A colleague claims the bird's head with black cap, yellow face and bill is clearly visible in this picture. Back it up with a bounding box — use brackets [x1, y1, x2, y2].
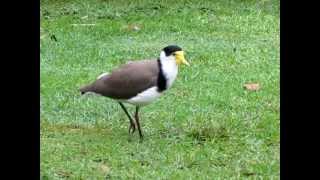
[160, 45, 190, 66]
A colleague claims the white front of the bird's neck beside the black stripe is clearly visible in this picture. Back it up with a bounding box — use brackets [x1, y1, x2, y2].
[160, 51, 178, 89]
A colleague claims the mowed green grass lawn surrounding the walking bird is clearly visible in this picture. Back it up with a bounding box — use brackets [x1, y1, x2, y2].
[40, 0, 280, 180]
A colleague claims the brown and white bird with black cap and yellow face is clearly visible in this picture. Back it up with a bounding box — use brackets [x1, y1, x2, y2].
[79, 45, 190, 139]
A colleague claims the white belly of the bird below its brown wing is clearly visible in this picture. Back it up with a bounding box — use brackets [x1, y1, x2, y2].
[120, 87, 161, 106]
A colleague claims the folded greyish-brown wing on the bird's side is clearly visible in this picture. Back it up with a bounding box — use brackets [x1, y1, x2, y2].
[86, 60, 159, 99]
